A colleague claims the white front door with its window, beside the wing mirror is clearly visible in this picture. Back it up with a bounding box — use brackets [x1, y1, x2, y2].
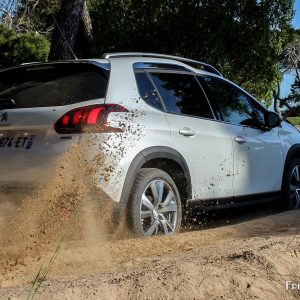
[201, 76, 283, 196]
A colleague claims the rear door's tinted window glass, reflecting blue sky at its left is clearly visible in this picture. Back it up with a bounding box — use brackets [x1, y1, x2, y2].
[149, 72, 214, 119]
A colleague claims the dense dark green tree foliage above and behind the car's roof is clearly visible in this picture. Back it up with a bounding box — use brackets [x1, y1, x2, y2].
[90, 0, 293, 99]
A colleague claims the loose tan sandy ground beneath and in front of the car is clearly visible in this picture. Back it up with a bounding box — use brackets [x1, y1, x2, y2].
[0, 197, 300, 299]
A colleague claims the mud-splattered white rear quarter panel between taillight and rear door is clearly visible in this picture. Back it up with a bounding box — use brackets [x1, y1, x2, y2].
[81, 59, 172, 202]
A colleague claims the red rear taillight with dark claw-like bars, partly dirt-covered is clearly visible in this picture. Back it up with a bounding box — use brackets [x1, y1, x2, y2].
[54, 104, 128, 134]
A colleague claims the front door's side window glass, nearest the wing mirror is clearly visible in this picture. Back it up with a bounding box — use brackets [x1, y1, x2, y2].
[201, 76, 259, 126]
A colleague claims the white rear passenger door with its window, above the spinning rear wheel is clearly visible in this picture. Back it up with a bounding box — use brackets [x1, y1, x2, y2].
[148, 71, 233, 199]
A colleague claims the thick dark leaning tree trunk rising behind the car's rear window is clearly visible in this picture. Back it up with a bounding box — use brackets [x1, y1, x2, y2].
[49, 0, 84, 60]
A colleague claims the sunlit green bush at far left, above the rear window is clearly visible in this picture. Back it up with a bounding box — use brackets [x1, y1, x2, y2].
[0, 25, 50, 67]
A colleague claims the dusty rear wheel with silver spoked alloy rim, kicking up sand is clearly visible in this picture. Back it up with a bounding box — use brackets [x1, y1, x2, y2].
[128, 168, 182, 236]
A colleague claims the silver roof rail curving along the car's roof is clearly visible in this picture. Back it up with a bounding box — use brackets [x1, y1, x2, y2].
[102, 52, 223, 76]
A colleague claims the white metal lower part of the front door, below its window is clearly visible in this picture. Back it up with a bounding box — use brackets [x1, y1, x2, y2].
[231, 125, 284, 196]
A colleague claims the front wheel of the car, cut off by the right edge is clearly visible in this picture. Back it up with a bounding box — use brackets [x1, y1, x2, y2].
[283, 158, 300, 210]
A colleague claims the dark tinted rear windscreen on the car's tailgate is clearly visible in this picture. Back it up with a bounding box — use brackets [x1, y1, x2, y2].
[0, 63, 108, 108]
